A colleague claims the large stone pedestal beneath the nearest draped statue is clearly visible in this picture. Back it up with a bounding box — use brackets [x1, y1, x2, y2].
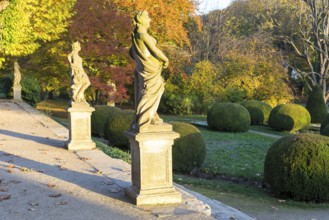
[125, 124, 182, 206]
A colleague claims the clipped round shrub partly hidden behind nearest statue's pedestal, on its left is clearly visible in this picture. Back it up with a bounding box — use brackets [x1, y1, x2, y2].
[104, 110, 134, 149]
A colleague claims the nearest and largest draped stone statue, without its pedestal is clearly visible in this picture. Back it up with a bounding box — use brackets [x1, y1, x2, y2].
[129, 11, 169, 132]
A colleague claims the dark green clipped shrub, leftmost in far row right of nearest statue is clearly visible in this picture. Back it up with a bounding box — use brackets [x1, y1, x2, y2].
[207, 103, 250, 132]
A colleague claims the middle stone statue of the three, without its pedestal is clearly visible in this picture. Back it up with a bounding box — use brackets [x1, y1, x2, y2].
[68, 42, 90, 105]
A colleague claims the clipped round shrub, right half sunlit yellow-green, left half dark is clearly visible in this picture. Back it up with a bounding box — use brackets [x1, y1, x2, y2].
[268, 104, 311, 131]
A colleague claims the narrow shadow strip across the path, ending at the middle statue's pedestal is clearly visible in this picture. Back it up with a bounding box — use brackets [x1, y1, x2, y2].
[0, 129, 66, 148]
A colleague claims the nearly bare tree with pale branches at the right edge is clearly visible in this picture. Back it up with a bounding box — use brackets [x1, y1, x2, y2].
[261, 0, 329, 101]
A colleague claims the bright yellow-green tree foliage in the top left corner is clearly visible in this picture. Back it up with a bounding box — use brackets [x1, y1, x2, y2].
[0, 0, 75, 57]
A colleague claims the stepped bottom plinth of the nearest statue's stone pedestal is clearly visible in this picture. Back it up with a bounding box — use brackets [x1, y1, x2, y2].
[125, 186, 182, 206]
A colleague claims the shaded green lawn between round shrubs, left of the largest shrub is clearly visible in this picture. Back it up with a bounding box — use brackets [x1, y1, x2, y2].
[200, 128, 277, 181]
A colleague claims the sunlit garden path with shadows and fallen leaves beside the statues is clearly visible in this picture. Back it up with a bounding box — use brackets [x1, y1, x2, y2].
[0, 101, 251, 220]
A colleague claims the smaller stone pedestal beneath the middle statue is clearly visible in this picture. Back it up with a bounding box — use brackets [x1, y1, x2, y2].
[67, 105, 96, 151]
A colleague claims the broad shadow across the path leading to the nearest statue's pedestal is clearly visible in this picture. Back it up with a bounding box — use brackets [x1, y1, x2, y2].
[0, 151, 131, 203]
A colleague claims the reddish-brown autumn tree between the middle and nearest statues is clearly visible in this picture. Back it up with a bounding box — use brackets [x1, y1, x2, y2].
[69, 0, 133, 103]
